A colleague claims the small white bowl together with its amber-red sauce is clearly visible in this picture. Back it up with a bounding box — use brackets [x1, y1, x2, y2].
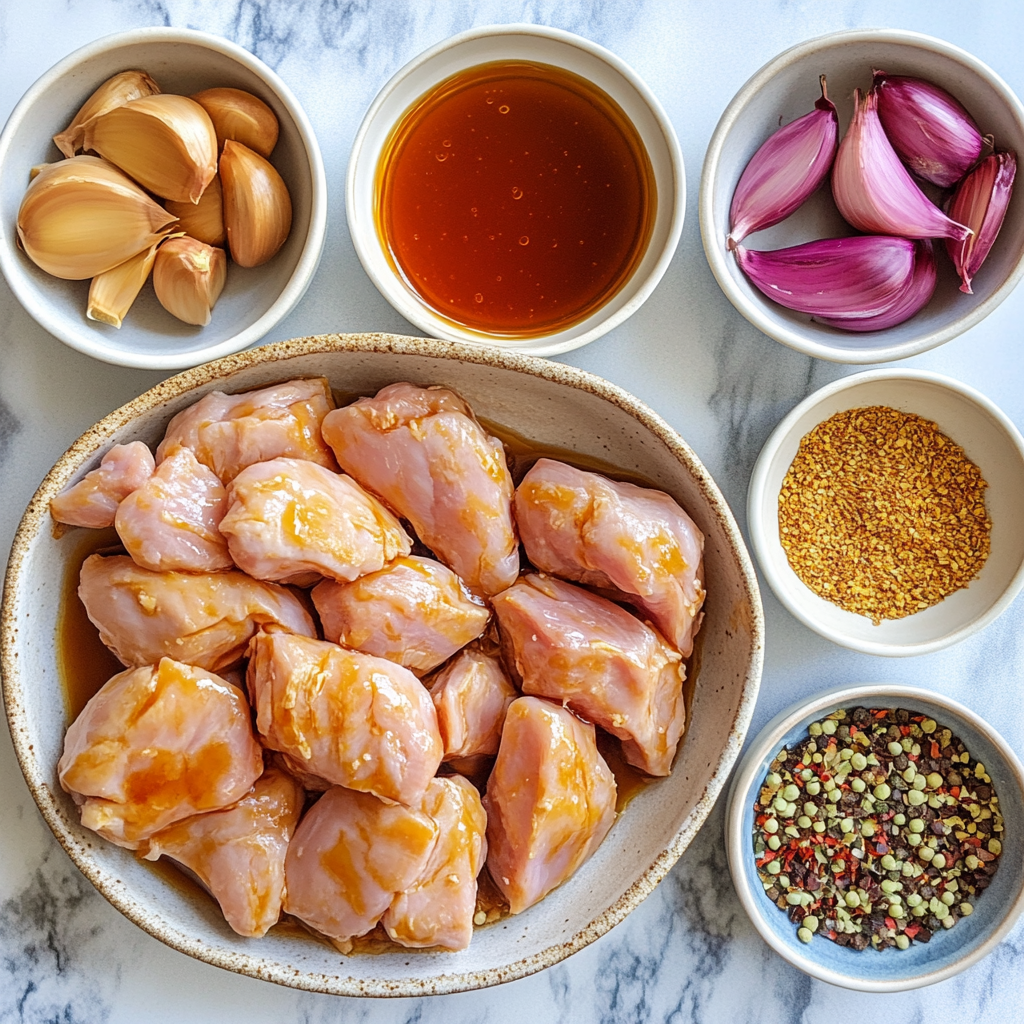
[346, 25, 686, 355]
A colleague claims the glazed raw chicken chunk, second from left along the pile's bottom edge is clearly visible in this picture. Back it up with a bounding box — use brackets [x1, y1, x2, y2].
[285, 786, 437, 942]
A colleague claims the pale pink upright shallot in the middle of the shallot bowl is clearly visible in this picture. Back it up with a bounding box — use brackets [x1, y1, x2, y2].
[833, 89, 970, 239]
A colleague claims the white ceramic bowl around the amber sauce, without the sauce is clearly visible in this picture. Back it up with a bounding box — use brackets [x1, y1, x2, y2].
[345, 25, 686, 355]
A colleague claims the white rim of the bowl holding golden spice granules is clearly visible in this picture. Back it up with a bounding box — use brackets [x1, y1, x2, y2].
[746, 368, 1024, 657]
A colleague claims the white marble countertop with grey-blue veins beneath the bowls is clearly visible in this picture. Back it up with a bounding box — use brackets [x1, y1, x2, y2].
[0, 0, 1024, 1024]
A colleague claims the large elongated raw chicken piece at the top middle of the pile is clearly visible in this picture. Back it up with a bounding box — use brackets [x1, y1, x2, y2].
[323, 384, 519, 595]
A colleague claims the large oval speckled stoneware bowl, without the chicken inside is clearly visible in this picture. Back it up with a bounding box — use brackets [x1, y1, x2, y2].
[0, 335, 763, 995]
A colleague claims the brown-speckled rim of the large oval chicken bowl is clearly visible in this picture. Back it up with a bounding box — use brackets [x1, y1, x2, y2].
[0, 334, 764, 996]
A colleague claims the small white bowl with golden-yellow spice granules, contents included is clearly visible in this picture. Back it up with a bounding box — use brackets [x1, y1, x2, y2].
[746, 370, 1024, 656]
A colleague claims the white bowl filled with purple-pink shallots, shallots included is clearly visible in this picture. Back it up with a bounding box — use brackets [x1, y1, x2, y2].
[699, 29, 1024, 364]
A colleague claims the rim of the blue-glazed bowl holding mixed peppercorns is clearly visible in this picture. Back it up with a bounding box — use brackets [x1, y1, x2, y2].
[725, 683, 1024, 992]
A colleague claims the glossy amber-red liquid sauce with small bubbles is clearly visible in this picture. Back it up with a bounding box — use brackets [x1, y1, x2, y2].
[374, 61, 656, 338]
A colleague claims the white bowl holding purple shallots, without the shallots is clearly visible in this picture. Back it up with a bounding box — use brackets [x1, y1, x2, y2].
[699, 29, 1024, 364]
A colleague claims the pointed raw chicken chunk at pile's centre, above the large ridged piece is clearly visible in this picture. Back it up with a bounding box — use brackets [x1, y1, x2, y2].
[312, 555, 490, 675]
